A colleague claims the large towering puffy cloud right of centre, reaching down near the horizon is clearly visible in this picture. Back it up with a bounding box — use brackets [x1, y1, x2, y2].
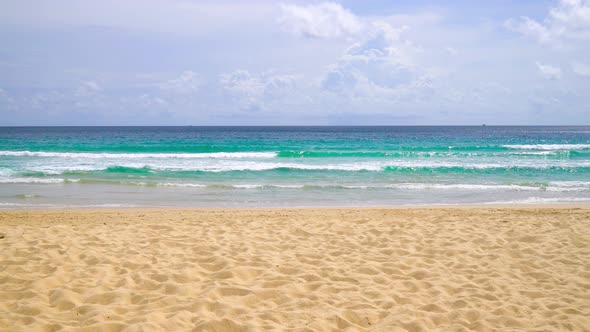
[316, 21, 462, 123]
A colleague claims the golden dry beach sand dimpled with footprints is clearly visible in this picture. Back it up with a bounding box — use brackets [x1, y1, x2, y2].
[0, 206, 590, 331]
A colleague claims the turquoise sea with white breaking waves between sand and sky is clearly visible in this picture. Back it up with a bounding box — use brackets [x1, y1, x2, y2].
[0, 126, 590, 208]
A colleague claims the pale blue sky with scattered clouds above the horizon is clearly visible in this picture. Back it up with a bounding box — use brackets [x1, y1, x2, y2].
[0, 0, 590, 126]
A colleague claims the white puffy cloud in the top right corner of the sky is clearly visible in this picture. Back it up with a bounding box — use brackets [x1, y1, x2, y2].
[506, 0, 590, 44]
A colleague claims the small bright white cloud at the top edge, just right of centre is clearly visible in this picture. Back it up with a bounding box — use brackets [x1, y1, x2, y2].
[279, 2, 363, 38]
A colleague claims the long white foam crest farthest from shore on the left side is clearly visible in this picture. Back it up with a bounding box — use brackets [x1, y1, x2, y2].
[0, 151, 277, 159]
